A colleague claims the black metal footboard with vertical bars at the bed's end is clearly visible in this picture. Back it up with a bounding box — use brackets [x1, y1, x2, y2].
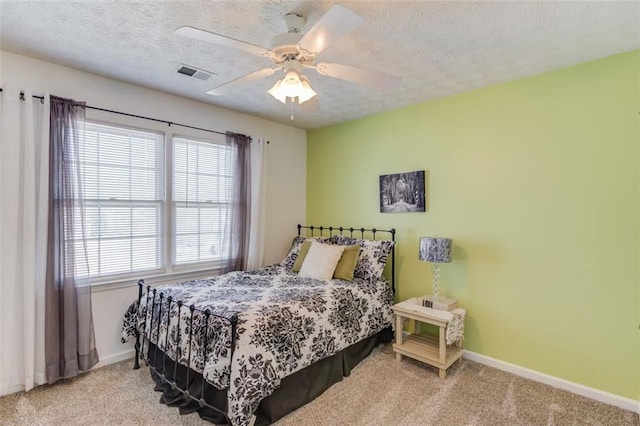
[133, 280, 238, 423]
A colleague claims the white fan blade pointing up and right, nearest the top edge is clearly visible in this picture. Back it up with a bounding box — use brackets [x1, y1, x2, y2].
[298, 4, 364, 54]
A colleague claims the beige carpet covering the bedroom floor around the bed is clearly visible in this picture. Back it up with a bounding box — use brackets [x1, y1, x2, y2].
[0, 347, 640, 426]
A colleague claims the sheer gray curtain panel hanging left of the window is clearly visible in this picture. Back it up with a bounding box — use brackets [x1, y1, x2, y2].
[45, 96, 98, 383]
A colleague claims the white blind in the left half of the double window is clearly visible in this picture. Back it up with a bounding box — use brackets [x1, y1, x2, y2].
[76, 122, 165, 277]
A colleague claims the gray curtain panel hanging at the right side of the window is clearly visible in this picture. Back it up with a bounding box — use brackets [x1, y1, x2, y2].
[222, 132, 251, 272]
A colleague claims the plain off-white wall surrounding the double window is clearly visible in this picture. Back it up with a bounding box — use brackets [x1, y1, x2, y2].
[0, 51, 307, 364]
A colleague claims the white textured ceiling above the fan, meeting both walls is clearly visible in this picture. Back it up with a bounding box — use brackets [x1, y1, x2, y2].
[0, 0, 640, 129]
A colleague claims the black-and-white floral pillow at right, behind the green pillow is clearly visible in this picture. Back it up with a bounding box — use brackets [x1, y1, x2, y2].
[329, 235, 395, 282]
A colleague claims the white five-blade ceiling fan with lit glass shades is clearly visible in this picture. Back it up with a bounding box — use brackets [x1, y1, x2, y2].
[175, 5, 399, 107]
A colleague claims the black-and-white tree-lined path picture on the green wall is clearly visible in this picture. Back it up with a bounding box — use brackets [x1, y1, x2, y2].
[380, 170, 426, 213]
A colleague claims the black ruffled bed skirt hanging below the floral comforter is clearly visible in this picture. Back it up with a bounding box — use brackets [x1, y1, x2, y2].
[148, 327, 393, 426]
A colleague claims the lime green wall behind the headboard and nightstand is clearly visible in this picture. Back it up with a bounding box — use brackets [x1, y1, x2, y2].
[307, 51, 640, 400]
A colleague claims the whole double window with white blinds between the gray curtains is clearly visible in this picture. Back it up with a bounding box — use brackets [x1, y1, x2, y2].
[75, 121, 233, 283]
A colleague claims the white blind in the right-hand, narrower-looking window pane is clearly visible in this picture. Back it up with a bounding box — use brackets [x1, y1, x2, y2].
[173, 137, 233, 265]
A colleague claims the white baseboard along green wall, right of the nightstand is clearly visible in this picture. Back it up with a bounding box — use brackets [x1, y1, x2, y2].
[462, 349, 640, 414]
